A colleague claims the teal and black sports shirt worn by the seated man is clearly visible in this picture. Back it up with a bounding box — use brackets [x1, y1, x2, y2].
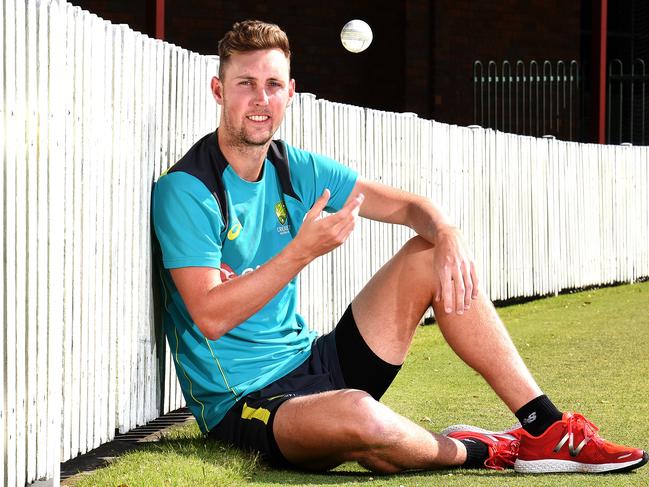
[152, 133, 357, 433]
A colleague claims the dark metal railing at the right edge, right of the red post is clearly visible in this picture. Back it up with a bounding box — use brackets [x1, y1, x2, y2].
[606, 58, 649, 145]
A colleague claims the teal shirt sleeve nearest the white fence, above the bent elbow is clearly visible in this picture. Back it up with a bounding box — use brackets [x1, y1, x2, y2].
[152, 172, 224, 269]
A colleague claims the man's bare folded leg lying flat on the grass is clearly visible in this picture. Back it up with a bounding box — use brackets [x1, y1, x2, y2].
[273, 389, 466, 473]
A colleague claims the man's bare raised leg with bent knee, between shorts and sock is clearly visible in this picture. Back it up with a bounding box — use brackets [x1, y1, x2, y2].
[352, 237, 542, 412]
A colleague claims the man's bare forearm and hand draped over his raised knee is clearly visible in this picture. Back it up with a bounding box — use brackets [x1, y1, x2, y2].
[348, 177, 478, 314]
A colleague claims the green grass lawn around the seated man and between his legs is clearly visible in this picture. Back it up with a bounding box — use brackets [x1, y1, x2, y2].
[67, 282, 649, 487]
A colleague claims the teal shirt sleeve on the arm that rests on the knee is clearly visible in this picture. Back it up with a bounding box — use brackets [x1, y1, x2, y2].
[287, 145, 358, 212]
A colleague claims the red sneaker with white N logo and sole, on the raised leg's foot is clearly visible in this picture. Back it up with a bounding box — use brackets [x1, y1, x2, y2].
[514, 413, 649, 473]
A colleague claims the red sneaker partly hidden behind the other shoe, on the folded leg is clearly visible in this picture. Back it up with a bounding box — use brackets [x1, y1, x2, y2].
[441, 424, 523, 470]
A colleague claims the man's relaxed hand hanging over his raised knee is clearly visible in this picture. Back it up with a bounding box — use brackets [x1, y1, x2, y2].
[433, 225, 478, 315]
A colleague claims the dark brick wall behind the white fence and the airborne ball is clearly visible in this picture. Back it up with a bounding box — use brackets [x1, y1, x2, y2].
[68, 0, 582, 125]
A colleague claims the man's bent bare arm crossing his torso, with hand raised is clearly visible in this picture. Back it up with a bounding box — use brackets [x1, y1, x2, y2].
[170, 190, 363, 340]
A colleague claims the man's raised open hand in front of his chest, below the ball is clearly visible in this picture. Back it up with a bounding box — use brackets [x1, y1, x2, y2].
[293, 189, 365, 260]
